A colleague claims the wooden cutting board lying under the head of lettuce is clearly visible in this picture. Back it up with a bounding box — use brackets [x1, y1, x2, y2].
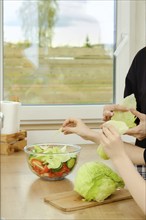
[44, 189, 132, 212]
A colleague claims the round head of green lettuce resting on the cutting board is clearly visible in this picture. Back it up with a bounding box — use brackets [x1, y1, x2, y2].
[74, 161, 124, 202]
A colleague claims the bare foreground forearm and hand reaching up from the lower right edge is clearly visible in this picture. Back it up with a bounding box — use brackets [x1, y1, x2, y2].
[101, 126, 146, 214]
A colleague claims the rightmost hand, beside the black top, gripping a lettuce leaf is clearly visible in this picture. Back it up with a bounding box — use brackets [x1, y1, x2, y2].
[125, 109, 146, 140]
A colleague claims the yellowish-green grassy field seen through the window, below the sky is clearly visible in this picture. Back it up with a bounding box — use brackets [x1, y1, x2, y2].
[4, 44, 113, 104]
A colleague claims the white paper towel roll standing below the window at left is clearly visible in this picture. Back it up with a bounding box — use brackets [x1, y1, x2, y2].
[0, 101, 21, 134]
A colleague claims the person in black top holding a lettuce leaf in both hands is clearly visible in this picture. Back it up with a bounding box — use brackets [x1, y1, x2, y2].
[103, 47, 146, 179]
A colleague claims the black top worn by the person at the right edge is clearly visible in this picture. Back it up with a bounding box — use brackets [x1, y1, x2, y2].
[124, 47, 146, 148]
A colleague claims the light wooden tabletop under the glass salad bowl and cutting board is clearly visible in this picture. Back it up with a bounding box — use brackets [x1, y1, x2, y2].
[1, 145, 145, 220]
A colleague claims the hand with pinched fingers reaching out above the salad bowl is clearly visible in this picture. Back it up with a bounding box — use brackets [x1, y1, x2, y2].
[61, 118, 99, 144]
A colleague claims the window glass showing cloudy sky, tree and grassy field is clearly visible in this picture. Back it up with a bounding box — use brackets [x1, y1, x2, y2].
[3, 0, 116, 105]
